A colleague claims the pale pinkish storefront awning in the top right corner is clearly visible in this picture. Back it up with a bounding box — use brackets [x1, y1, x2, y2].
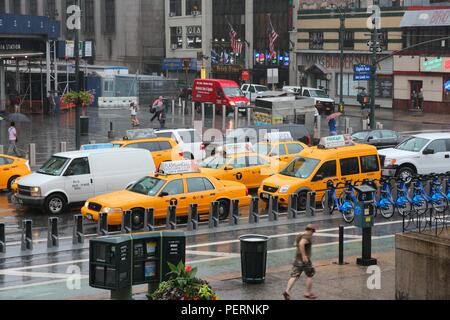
[400, 9, 450, 28]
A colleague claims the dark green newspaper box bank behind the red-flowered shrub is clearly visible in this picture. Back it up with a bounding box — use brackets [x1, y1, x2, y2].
[89, 231, 186, 300]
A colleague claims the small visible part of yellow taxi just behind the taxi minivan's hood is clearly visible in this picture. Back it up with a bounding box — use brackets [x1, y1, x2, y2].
[255, 132, 308, 162]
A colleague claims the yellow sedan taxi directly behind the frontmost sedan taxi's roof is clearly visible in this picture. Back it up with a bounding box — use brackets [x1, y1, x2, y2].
[199, 143, 287, 189]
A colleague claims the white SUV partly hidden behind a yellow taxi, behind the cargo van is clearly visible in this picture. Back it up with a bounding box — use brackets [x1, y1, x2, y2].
[155, 129, 206, 161]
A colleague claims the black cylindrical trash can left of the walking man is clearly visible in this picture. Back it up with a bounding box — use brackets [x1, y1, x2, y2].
[240, 235, 269, 284]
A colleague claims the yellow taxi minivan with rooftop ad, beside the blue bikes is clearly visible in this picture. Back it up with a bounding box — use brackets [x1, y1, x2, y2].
[258, 135, 381, 210]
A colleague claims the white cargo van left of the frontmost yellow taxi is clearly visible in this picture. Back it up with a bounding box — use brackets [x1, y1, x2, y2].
[16, 148, 155, 214]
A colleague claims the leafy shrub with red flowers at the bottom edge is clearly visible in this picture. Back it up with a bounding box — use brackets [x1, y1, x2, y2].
[149, 262, 218, 300]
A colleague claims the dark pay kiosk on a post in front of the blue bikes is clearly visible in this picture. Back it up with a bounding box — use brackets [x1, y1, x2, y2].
[355, 184, 377, 266]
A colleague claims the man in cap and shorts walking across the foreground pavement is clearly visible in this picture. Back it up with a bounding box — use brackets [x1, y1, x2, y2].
[283, 224, 317, 300]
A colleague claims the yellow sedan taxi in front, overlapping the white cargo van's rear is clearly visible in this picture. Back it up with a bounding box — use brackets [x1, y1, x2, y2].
[81, 160, 251, 229]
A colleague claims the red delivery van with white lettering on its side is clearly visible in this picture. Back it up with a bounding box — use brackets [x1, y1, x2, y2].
[192, 79, 250, 115]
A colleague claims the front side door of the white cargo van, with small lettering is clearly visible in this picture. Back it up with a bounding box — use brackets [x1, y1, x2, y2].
[63, 157, 95, 203]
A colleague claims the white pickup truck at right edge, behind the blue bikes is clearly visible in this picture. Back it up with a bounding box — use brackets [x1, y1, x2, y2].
[379, 133, 450, 183]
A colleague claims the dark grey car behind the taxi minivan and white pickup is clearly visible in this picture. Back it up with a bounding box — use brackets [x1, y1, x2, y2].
[352, 130, 404, 149]
